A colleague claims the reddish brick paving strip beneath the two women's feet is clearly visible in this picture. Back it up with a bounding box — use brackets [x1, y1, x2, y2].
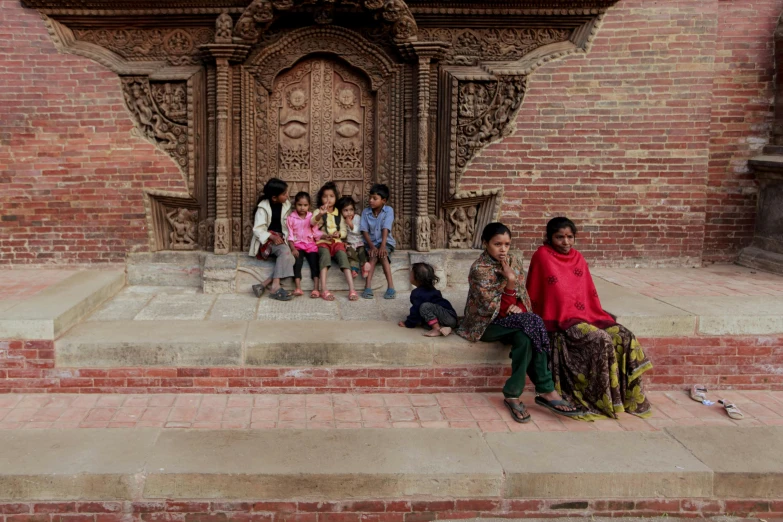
[0, 391, 783, 432]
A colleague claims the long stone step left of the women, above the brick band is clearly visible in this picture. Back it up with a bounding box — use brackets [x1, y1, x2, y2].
[55, 321, 508, 368]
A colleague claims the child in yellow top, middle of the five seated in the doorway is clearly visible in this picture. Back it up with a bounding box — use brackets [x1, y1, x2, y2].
[310, 181, 359, 301]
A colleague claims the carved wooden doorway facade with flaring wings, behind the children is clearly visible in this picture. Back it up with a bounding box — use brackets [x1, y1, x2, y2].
[23, 0, 616, 254]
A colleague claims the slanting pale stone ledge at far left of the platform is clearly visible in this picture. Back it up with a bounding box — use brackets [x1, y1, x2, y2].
[0, 270, 125, 340]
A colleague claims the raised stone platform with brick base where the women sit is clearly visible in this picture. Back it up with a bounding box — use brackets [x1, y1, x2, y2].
[0, 264, 783, 393]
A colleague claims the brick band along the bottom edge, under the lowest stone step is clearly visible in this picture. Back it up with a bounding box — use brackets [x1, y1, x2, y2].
[0, 498, 783, 522]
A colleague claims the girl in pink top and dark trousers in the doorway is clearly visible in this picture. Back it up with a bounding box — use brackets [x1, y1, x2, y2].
[286, 192, 321, 299]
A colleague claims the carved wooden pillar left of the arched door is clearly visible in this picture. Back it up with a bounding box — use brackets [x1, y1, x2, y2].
[203, 13, 250, 254]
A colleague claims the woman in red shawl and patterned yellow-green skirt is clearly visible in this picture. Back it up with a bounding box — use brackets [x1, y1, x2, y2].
[527, 217, 652, 420]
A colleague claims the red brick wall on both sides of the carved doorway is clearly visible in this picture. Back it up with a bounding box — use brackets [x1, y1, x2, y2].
[0, 0, 783, 266]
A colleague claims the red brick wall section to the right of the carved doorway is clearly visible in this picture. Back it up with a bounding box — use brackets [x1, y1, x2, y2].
[462, 0, 783, 264]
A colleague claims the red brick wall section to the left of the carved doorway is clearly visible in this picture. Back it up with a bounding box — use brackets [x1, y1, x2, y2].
[0, 0, 185, 266]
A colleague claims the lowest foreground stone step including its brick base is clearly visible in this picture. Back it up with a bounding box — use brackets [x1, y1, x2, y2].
[0, 412, 783, 512]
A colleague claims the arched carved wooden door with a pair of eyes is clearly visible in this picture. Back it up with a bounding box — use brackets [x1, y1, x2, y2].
[266, 57, 375, 202]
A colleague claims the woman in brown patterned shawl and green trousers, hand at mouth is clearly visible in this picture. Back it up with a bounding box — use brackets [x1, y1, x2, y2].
[457, 223, 580, 423]
